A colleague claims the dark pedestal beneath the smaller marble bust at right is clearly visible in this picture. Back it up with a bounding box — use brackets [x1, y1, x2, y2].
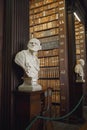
[70, 83, 84, 123]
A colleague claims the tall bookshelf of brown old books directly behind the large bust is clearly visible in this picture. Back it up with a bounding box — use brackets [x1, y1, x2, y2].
[29, 0, 68, 115]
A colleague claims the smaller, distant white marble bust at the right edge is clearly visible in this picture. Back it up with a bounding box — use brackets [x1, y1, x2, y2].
[75, 59, 85, 82]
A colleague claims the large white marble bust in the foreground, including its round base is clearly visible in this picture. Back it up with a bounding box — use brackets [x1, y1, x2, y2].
[15, 38, 42, 91]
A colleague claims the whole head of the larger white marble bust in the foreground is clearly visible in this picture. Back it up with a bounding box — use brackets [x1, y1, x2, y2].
[27, 38, 41, 52]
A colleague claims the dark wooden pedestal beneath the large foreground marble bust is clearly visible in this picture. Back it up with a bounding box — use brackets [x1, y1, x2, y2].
[14, 91, 44, 130]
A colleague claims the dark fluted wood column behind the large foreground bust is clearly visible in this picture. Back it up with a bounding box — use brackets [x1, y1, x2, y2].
[1, 0, 29, 130]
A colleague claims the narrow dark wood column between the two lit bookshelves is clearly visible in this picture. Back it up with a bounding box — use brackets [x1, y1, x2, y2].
[67, 11, 76, 109]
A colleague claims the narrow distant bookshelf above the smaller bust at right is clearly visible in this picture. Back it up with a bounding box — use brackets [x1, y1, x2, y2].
[75, 18, 85, 61]
